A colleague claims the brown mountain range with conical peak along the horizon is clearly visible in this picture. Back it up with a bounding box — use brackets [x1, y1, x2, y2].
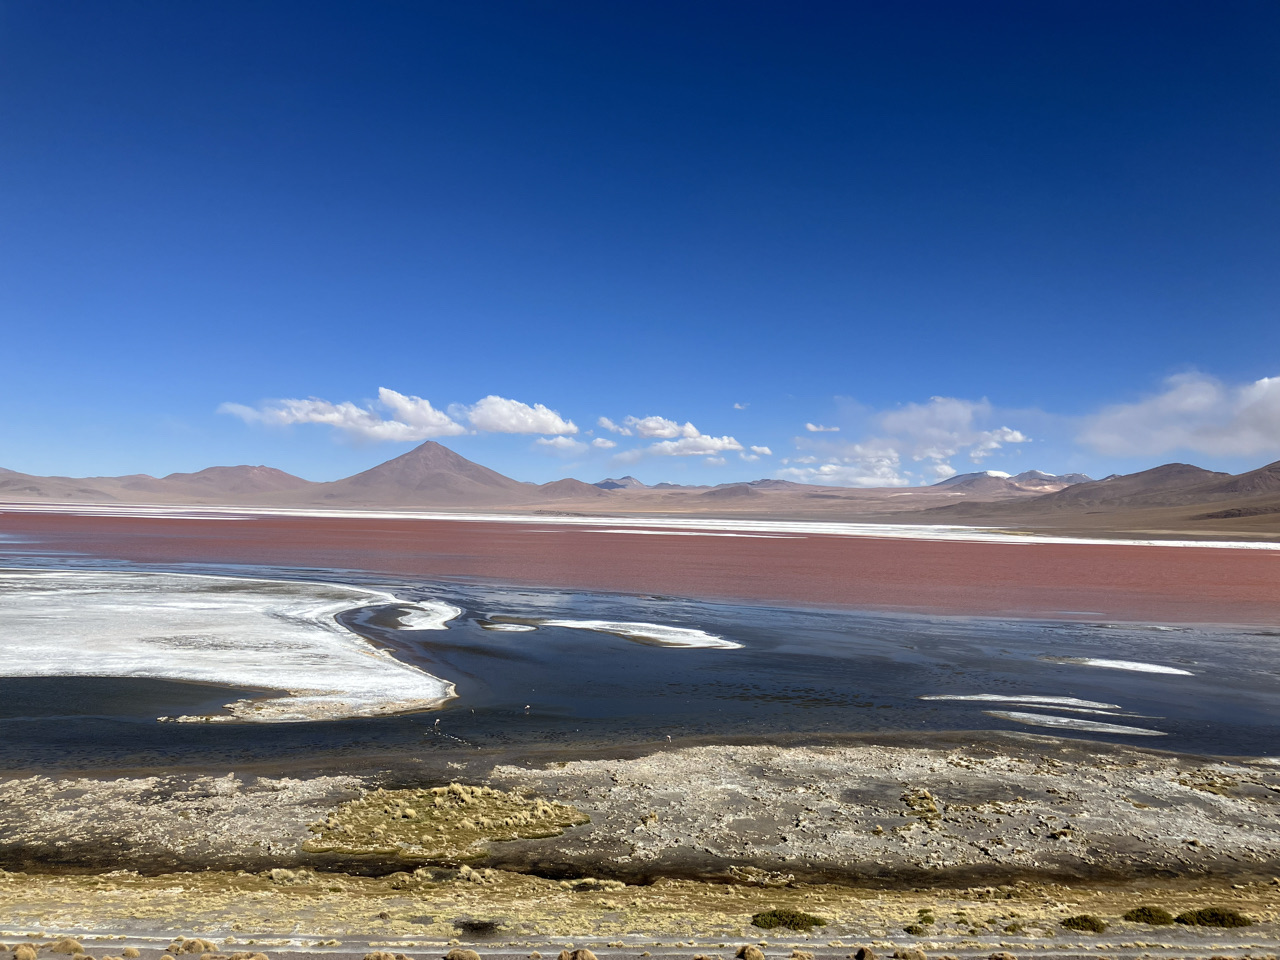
[0, 440, 1280, 536]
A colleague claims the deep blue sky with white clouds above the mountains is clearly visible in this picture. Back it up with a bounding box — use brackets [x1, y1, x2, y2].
[0, 0, 1280, 485]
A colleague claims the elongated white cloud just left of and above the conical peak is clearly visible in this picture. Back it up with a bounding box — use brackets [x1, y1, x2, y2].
[218, 387, 467, 442]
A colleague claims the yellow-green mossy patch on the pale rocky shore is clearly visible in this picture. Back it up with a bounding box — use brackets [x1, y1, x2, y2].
[303, 783, 590, 860]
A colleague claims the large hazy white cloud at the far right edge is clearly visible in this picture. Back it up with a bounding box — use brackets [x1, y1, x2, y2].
[1078, 372, 1280, 457]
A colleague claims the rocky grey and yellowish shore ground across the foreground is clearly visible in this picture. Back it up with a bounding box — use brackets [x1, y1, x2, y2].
[0, 733, 1280, 960]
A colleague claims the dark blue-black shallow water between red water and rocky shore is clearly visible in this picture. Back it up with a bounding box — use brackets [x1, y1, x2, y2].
[0, 563, 1280, 769]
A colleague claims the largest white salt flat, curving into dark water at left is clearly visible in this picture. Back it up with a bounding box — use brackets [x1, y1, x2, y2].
[0, 570, 454, 722]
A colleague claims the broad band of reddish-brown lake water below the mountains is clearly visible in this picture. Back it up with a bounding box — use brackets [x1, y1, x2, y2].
[0, 512, 1280, 625]
